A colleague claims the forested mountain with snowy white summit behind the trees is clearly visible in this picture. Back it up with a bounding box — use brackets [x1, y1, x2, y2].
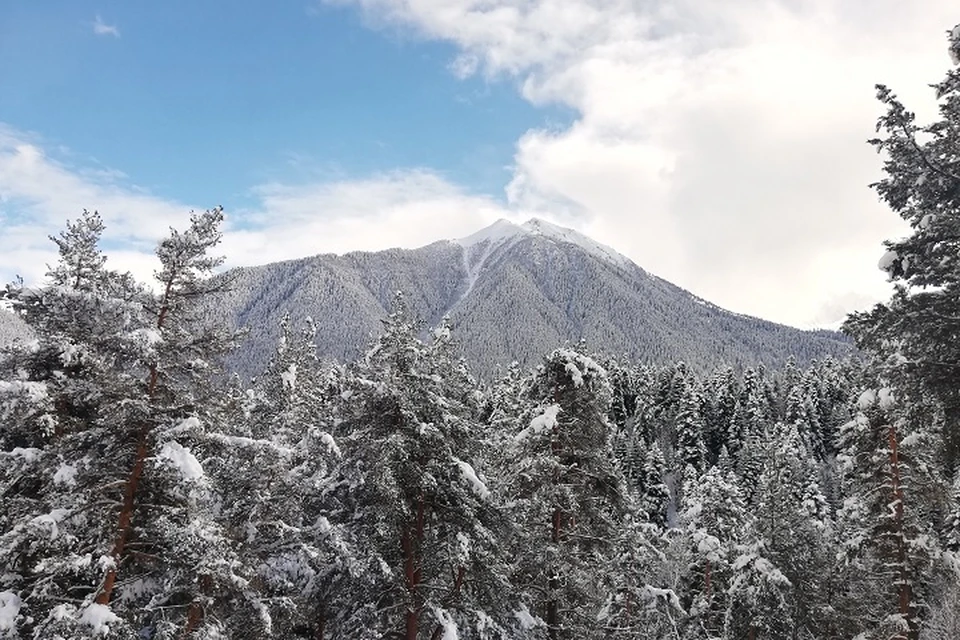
[206, 219, 852, 374]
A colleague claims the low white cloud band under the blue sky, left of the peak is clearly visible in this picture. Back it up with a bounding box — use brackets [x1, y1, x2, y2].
[0, 127, 517, 282]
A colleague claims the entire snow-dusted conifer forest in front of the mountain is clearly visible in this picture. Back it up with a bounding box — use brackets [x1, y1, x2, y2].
[0, 25, 960, 640]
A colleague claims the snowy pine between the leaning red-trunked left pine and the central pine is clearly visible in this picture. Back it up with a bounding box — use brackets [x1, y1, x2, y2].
[211, 318, 348, 640]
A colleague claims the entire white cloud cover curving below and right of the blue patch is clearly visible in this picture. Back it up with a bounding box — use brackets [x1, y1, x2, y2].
[0, 0, 960, 326]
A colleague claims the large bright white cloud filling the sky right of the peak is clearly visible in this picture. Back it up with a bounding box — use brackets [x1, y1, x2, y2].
[326, 0, 956, 325]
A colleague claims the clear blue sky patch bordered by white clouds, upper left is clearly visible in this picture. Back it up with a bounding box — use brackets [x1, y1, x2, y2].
[0, 0, 563, 208]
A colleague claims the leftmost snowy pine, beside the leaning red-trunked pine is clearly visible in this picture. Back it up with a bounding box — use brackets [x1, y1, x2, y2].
[0, 211, 152, 638]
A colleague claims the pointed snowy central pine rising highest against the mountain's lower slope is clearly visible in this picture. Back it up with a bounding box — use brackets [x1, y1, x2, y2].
[331, 294, 532, 640]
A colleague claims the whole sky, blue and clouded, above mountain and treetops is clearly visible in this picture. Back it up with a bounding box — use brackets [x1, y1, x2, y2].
[0, 0, 960, 326]
